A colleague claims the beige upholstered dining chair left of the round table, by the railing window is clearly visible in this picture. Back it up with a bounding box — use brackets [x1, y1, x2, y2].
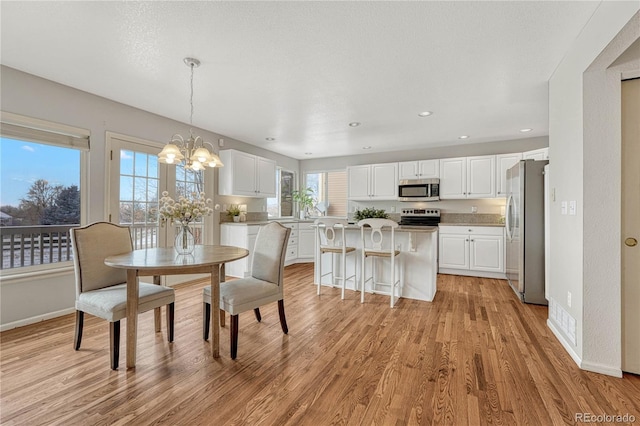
[71, 222, 175, 370]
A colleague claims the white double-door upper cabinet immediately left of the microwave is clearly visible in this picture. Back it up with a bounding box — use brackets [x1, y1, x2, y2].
[347, 163, 398, 200]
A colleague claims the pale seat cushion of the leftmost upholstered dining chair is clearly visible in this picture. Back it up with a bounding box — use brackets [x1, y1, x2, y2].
[76, 282, 175, 322]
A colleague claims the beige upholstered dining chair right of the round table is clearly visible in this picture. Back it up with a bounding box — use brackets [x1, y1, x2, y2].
[202, 222, 291, 359]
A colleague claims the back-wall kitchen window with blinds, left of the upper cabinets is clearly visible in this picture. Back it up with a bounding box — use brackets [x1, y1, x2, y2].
[304, 170, 347, 217]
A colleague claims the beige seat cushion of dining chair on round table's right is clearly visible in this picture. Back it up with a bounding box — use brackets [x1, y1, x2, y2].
[202, 277, 282, 315]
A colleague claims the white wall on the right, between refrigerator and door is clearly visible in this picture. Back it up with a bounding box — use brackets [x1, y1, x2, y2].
[549, 2, 640, 376]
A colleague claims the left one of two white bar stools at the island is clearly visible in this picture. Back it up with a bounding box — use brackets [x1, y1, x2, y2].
[314, 218, 357, 299]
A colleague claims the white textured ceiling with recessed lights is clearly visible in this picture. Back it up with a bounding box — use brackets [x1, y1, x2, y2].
[0, 1, 599, 159]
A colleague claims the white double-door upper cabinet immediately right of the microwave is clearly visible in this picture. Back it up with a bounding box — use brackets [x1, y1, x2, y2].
[440, 155, 496, 199]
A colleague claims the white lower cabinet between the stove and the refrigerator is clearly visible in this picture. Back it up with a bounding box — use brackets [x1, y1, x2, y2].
[438, 225, 504, 278]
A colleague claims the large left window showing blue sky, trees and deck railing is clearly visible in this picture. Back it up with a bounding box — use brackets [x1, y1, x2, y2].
[0, 112, 89, 270]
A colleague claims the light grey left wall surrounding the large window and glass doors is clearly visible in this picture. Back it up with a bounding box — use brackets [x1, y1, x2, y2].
[0, 66, 298, 330]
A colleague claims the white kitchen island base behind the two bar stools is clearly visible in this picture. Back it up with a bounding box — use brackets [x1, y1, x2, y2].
[314, 225, 438, 302]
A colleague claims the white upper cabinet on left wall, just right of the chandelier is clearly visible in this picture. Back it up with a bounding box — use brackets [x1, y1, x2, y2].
[218, 149, 276, 198]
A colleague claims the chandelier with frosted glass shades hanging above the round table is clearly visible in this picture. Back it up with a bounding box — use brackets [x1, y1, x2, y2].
[158, 58, 224, 171]
